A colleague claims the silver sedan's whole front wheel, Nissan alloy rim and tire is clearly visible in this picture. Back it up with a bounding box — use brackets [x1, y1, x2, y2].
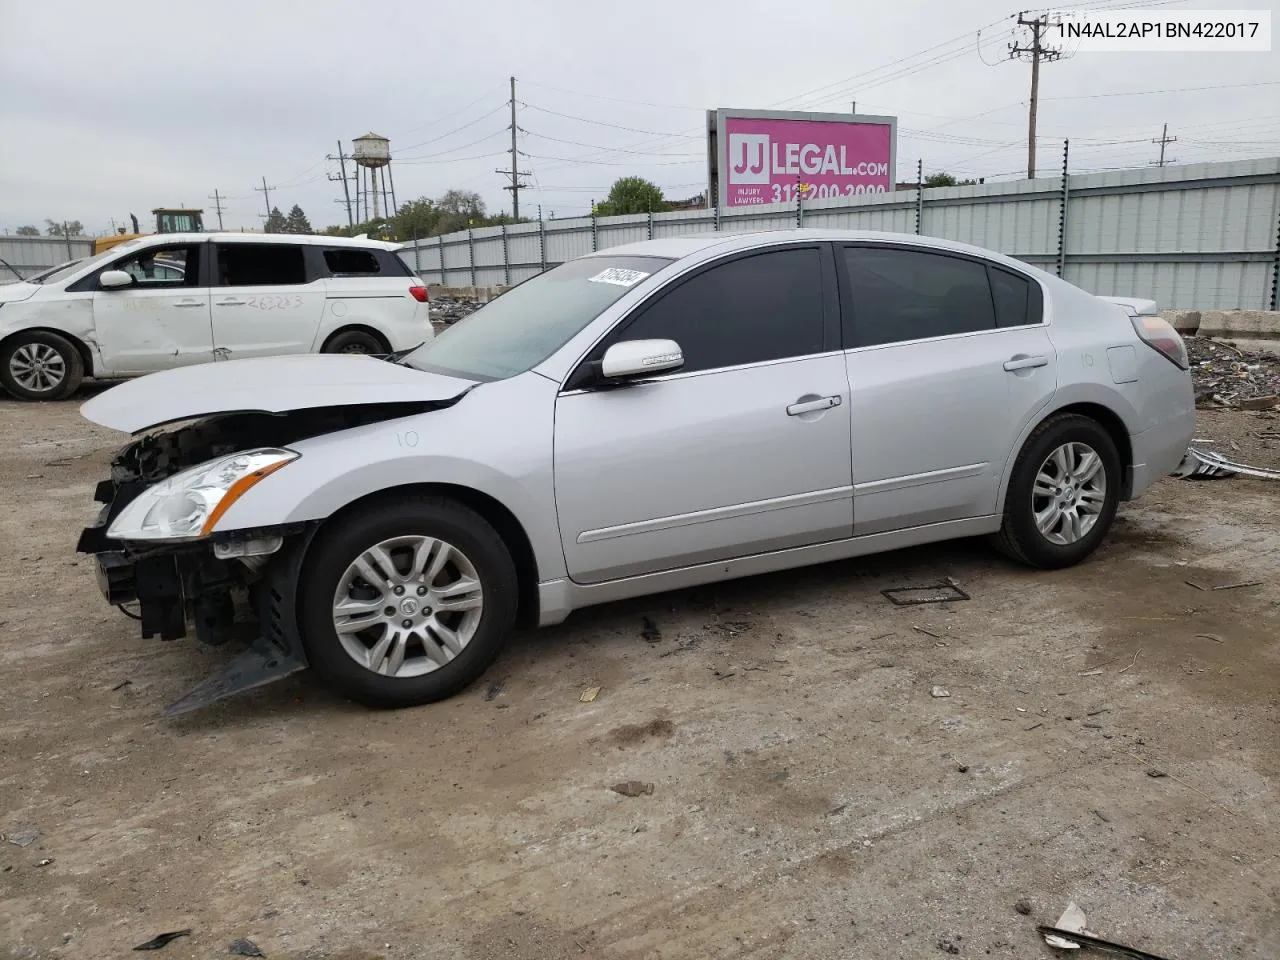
[298, 497, 517, 708]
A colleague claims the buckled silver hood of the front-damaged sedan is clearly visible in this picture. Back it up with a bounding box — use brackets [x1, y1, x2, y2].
[81, 353, 476, 434]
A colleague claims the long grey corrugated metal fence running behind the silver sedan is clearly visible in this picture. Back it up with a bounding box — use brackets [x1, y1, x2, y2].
[402, 157, 1280, 310]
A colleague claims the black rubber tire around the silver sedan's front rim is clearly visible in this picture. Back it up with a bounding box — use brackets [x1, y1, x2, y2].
[298, 495, 518, 708]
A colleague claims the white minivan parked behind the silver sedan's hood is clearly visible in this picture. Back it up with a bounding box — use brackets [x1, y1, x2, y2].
[0, 233, 431, 401]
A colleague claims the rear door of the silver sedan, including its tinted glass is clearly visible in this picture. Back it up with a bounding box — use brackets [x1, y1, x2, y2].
[840, 244, 1057, 535]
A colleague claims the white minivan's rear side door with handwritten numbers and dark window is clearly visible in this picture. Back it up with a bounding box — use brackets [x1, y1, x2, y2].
[212, 241, 325, 360]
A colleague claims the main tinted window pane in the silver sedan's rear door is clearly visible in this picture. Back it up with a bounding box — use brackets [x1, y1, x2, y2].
[845, 247, 996, 347]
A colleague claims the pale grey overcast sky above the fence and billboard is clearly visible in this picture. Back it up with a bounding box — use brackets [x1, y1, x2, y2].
[0, 0, 1280, 233]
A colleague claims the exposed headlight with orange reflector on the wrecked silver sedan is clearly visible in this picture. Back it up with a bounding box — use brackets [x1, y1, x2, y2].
[106, 449, 298, 541]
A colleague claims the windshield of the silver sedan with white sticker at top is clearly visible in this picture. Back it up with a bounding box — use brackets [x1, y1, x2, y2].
[401, 256, 672, 380]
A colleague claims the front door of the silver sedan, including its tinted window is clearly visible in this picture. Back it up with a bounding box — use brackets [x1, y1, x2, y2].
[554, 244, 852, 582]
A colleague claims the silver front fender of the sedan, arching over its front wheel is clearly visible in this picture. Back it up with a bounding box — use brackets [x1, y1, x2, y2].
[215, 374, 564, 580]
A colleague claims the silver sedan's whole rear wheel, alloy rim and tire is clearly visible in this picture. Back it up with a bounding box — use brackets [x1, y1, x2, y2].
[996, 413, 1121, 570]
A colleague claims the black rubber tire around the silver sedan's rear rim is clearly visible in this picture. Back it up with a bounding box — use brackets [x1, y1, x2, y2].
[995, 413, 1123, 570]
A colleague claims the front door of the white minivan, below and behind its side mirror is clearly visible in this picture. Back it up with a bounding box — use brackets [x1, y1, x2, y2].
[91, 243, 214, 376]
